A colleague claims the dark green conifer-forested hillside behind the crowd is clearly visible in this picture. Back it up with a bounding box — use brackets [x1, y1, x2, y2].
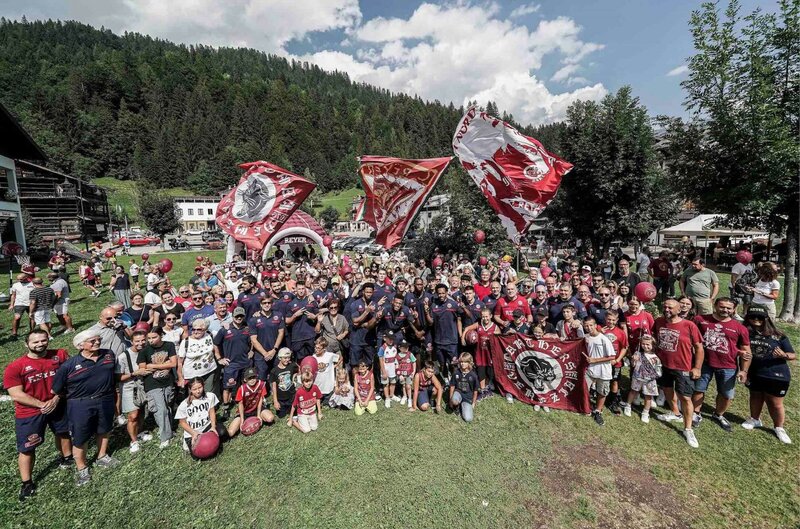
[0, 19, 560, 197]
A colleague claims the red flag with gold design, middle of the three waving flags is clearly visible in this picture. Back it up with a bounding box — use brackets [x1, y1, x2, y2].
[358, 156, 452, 249]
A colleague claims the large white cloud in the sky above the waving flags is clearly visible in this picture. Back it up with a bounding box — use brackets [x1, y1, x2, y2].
[301, 3, 607, 123]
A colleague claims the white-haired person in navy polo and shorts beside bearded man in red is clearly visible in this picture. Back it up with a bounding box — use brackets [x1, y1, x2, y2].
[52, 328, 119, 487]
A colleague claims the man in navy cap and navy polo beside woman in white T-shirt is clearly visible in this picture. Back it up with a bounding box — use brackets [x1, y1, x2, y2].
[214, 307, 252, 407]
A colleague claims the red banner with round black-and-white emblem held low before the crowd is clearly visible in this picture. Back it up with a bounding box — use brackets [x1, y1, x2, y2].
[484, 334, 591, 413]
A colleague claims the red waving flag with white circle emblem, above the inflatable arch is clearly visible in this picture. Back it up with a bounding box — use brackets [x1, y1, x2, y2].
[217, 161, 316, 251]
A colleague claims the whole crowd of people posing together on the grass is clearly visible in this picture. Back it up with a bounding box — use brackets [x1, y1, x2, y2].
[3, 243, 796, 499]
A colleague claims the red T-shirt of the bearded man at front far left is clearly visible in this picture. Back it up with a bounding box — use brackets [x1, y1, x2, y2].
[3, 349, 69, 419]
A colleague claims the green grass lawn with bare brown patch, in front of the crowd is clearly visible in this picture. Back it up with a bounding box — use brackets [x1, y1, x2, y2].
[0, 254, 800, 529]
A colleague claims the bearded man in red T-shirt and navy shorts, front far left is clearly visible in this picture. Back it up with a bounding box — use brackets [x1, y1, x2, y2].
[3, 329, 74, 501]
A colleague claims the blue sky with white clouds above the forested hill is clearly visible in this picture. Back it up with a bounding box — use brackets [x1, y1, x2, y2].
[0, 0, 777, 123]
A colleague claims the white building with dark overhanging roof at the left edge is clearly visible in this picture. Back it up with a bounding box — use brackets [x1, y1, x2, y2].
[0, 105, 47, 249]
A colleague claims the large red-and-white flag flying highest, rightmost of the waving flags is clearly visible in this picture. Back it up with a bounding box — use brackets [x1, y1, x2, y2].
[453, 107, 572, 241]
